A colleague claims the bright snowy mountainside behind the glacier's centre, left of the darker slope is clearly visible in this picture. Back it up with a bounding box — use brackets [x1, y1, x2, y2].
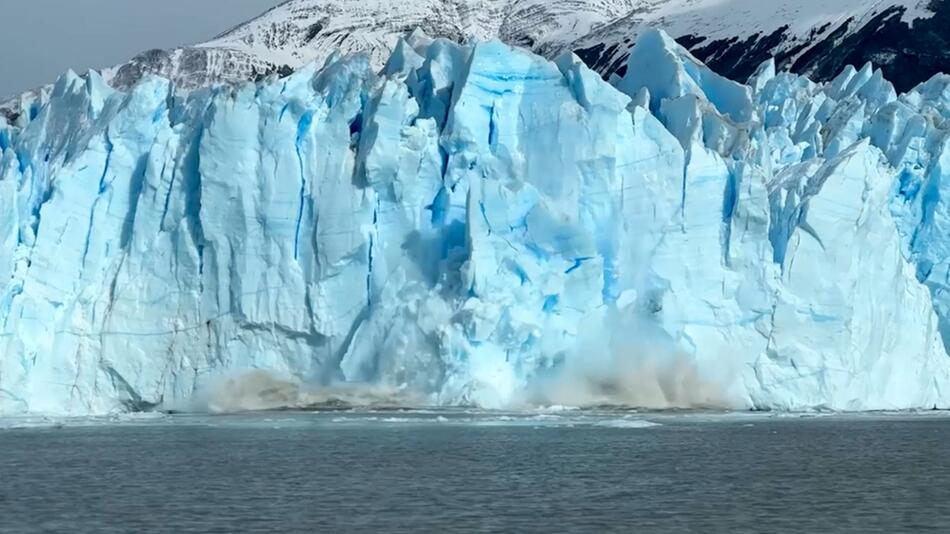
[200, 0, 642, 67]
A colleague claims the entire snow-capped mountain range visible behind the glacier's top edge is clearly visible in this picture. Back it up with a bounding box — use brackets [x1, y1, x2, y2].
[0, 0, 950, 119]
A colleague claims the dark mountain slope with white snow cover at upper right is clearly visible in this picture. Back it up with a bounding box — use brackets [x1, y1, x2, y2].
[574, 0, 950, 91]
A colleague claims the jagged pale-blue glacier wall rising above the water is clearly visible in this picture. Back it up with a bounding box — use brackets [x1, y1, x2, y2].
[0, 30, 950, 415]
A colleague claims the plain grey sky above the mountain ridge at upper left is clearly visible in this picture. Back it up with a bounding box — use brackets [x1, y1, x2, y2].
[0, 0, 282, 99]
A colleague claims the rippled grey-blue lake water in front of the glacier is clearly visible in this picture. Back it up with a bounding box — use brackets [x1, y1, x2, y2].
[0, 411, 950, 533]
